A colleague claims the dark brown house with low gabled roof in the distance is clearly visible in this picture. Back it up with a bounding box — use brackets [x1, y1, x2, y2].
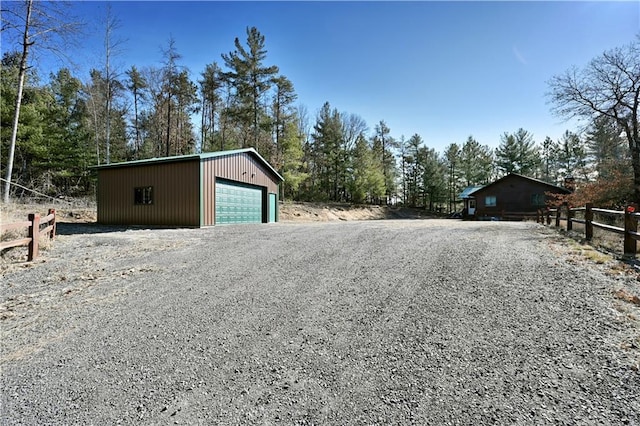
[465, 173, 571, 218]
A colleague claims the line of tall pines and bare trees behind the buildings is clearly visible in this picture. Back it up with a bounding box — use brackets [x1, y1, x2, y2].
[0, 1, 640, 211]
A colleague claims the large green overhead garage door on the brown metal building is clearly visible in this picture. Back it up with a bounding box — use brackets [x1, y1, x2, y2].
[216, 181, 262, 225]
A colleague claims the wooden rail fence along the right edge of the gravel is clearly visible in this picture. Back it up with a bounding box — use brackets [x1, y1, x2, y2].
[538, 203, 640, 256]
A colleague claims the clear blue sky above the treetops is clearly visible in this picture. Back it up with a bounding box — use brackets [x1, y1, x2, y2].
[32, 1, 640, 152]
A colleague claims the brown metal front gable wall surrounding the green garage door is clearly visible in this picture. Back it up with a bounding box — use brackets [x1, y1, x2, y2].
[202, 153, 278, 226]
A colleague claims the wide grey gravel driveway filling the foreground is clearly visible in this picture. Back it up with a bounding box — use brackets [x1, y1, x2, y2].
[0, 220, 640, 425]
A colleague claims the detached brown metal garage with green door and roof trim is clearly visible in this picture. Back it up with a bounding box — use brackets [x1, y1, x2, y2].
[96, 148, 284, 227]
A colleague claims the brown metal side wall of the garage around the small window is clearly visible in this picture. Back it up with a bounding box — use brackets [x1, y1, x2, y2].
[98, 159, 200, 226]
